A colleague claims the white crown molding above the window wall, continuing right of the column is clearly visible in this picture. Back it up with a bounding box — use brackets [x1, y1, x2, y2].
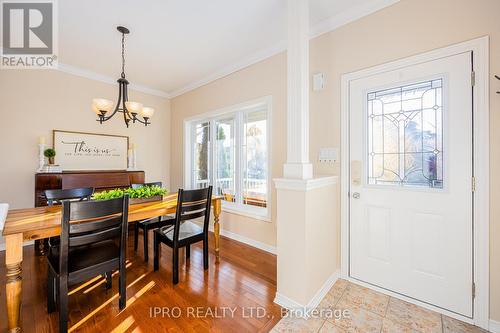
[169, 0, 400, 98]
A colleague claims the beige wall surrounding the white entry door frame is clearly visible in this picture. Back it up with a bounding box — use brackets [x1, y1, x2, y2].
[310, 0, 500, 321]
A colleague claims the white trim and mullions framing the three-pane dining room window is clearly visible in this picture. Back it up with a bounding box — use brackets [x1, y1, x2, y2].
[183, 96, 273, 222]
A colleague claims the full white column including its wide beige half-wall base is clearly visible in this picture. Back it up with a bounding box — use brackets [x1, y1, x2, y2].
[274, 0, 339, 310]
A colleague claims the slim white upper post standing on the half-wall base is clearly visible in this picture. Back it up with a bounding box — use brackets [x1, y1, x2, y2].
[283, 0, 312, 179]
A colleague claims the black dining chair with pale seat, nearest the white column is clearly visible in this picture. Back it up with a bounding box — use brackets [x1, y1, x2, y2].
[154, 186, 212, 284]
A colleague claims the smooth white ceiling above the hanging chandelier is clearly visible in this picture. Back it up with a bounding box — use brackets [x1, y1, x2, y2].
[58, 0, 398, 96]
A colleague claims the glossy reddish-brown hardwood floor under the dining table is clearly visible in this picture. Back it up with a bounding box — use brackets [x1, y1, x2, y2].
[0, 232, 281, 333]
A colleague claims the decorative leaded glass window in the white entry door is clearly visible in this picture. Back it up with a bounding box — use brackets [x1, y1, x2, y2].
[367, 79, 443, 188]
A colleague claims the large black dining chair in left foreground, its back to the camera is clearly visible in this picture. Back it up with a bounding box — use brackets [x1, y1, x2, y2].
[47, 195, 129, 333]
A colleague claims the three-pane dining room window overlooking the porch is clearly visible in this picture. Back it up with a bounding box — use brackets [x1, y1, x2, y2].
[186, 99, 270, 216]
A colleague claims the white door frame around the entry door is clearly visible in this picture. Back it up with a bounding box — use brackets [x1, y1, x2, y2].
[340, 36, 490, 329]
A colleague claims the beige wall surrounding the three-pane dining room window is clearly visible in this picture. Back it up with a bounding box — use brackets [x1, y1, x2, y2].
[170, 54, 286, 246]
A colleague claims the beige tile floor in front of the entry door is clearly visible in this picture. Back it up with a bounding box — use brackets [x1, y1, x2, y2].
[271, 279, 486, 333]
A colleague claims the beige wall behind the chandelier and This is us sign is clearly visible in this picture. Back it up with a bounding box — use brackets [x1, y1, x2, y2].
[0, 70, 170, 208]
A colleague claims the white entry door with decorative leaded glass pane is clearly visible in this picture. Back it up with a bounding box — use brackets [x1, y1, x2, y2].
[349, 52, 473, 317]
